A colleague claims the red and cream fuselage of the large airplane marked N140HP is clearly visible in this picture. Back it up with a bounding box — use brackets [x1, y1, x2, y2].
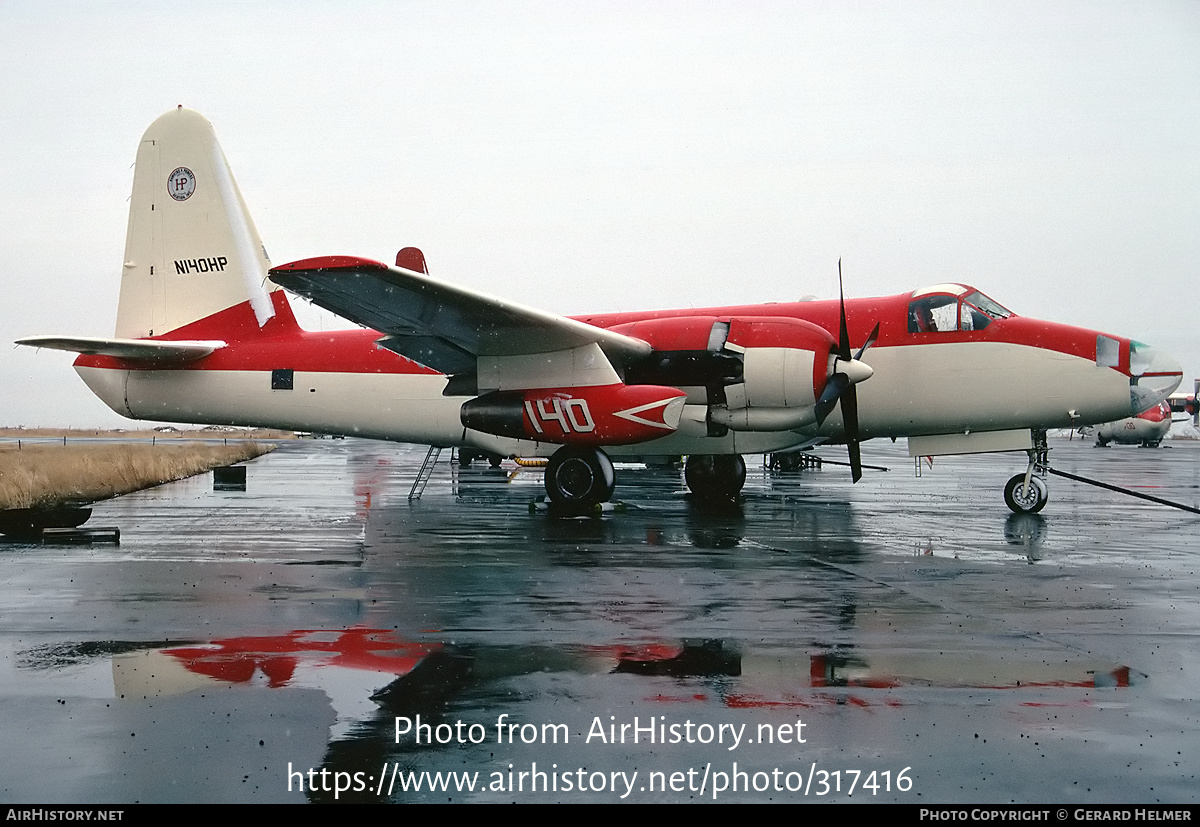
[76, 286, 1152, 456]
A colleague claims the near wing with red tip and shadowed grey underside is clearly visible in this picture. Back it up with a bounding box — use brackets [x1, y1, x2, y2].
[270, 256, 652, 374]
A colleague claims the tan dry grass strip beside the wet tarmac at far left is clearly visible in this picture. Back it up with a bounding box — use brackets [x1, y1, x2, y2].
[0, 439, 275, 510]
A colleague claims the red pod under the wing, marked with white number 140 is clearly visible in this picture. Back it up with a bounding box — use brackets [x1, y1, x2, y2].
[460, 384, 686, 445]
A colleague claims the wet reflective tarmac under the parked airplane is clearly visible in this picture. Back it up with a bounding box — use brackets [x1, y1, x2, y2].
[0, 439, 1200, 804]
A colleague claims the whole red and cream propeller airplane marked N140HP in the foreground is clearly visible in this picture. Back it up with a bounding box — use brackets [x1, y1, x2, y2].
[20, 108, 1181, 510]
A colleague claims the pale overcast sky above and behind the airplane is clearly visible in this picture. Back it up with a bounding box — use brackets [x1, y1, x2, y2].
[0, 0, 1200, 426]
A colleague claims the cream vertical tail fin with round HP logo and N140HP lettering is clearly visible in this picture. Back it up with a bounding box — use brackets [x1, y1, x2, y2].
[116, 107, 277, 338]
